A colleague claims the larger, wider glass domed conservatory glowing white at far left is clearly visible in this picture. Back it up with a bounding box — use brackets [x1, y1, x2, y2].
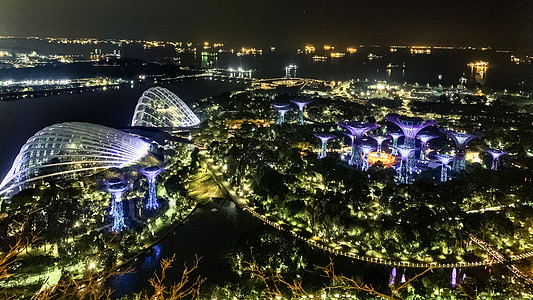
[0, 123, 151, 195]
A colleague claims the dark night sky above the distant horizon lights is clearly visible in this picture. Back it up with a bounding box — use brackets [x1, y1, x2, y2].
[0, 0, 533, 48]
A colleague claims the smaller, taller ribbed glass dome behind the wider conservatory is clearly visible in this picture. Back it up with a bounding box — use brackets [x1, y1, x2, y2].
[131, 87, 200, 127]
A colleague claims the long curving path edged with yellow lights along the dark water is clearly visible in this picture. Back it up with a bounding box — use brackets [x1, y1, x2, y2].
[202, 151, 501, 269]
